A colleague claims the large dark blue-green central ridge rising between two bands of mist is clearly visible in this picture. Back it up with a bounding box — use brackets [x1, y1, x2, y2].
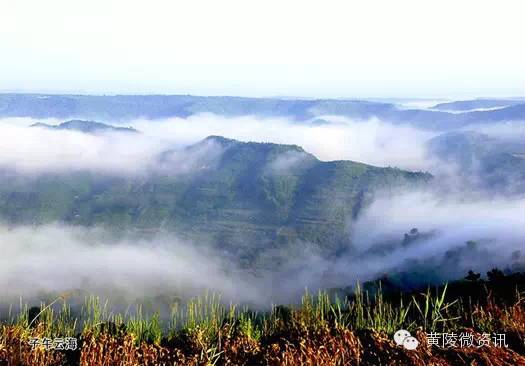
[0, 136, 431, 264]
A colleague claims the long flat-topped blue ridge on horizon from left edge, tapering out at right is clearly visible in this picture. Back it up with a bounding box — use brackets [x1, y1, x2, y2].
[0, 94, 393, 121]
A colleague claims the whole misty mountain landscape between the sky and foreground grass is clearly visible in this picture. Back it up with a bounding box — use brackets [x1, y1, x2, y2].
[0, 94, 525, 307]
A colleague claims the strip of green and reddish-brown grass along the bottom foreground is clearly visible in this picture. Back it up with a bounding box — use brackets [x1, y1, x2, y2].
[0, 288, 525, 366]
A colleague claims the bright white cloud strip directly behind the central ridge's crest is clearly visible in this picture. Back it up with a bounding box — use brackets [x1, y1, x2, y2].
[131, 114, 435, 169]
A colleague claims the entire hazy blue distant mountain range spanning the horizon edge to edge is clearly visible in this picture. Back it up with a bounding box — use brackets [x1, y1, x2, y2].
[4, 94, 525, 130]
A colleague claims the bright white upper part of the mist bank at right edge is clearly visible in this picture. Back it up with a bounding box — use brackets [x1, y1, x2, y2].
[353, 191, 525, 252]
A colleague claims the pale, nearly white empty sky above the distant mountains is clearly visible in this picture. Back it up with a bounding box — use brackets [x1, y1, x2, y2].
[0, 0, 525, 98]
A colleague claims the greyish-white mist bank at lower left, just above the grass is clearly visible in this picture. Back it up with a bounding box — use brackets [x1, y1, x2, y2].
[0, 224, 261, 303]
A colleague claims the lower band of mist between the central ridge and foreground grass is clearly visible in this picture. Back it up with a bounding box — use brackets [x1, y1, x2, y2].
[0, 192, 525, 309]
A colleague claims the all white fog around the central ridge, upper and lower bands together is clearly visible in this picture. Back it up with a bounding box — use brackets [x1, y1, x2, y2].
[0, 115, 525, 306]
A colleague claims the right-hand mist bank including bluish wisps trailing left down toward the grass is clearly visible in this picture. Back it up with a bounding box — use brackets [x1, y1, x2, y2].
[266, 191, 525, 296]
